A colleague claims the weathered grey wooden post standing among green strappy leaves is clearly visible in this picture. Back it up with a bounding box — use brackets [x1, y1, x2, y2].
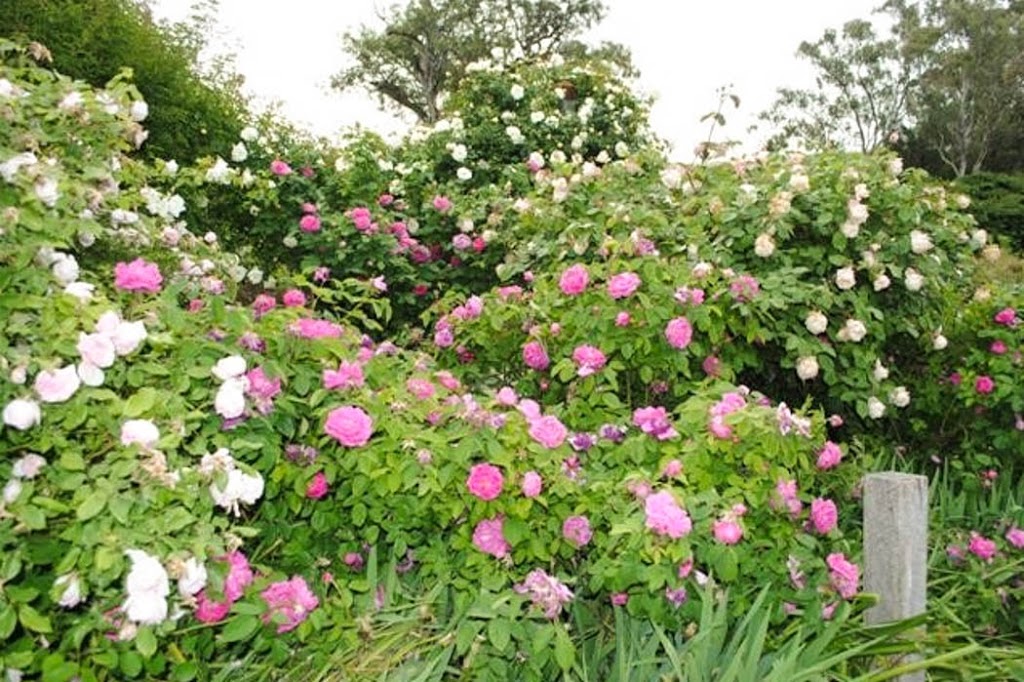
[864, 472, 928, 682]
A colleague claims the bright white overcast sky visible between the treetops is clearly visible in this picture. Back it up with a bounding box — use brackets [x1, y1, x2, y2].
[151, 0, 881, 157]
